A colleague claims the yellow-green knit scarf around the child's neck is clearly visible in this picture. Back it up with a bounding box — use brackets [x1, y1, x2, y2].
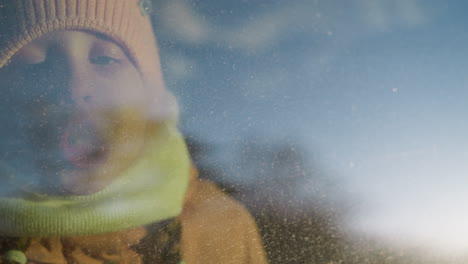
[0, 124, 190, 237]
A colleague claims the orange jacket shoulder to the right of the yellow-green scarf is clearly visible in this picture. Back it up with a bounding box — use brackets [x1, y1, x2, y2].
[182, 178, 267, 264]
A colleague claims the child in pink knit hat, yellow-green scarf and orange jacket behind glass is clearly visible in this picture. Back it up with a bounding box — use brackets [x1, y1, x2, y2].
[0, 0, 266, 264]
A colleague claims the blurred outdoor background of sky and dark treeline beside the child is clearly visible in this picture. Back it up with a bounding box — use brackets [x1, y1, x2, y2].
[154, 0, 468, 263]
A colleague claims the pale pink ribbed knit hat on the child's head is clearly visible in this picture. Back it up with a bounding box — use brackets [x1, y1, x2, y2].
[0, 0, 162, 83]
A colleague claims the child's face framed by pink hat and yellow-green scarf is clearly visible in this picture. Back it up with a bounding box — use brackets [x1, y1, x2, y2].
[0, 31, 153, 195]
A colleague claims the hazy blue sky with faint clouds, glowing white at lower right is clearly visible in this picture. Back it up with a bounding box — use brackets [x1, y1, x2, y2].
[156, 0, 468, 252]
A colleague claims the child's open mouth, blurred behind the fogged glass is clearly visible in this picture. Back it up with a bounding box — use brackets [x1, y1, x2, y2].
[60, 117, 108, 169]
